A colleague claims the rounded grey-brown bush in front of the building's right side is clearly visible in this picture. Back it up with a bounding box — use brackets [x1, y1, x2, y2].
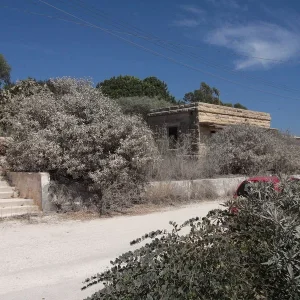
[206, 125, 300, 175]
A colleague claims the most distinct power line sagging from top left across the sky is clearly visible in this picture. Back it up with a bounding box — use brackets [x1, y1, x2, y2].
[38, 0, 300, 101]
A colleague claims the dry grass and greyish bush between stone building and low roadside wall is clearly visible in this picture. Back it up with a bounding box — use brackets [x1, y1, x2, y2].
[149, 124, 300, 181]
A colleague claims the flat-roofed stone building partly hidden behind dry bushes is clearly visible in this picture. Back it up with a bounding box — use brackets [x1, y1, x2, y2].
[147, 103, 271, 150]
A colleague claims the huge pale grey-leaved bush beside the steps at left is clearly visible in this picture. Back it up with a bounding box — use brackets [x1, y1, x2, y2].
[4, 78, 156, 212]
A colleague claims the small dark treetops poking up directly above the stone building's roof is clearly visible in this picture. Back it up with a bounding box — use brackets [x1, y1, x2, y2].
[183, 82, 247, 109]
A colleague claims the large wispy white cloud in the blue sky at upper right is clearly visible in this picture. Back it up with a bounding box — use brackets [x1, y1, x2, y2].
[205, 22, 300, 70]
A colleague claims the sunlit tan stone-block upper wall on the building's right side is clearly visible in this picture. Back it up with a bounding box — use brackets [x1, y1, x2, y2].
[198, 103, 271, 128]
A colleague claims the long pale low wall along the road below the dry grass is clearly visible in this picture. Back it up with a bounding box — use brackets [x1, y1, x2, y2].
[146, 177, 247, 200]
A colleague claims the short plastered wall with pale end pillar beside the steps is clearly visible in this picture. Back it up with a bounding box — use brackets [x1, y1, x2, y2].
[7, 172, 53, 212]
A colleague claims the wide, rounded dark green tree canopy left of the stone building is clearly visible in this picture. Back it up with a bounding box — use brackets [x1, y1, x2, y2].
[96, 75, 176, 103]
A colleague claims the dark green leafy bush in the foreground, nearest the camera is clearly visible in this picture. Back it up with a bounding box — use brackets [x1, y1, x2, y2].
[83, 178, 300, 300]
